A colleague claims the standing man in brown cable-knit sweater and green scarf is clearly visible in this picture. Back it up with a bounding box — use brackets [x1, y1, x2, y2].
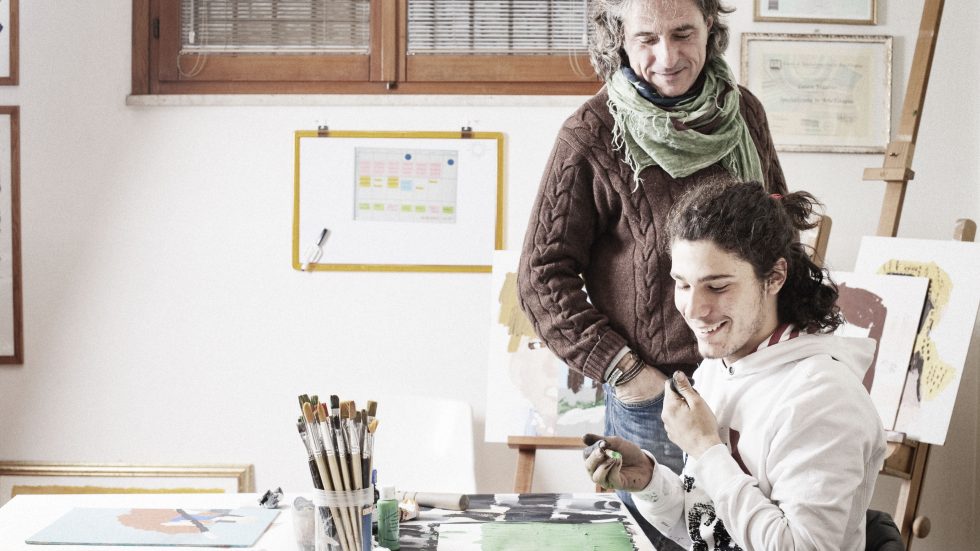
[518, 0, 786, 549]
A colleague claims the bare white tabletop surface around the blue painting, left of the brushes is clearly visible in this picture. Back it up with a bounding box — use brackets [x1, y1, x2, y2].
[0, 494, 298, 551]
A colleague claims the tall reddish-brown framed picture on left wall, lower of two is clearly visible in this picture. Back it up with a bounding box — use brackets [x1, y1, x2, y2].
[0, 105, 24, 364]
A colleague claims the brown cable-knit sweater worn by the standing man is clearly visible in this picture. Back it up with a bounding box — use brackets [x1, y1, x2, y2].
[518, 87, 786, 381]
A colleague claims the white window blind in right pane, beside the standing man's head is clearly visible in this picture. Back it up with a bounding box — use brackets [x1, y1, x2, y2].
[408, 0, 587, 55]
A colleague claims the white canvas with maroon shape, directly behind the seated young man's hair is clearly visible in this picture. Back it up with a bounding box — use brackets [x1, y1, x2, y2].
[831, 272, 929, 430]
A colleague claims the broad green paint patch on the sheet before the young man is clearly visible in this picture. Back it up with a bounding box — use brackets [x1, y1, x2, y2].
[439, 522, 635, 551]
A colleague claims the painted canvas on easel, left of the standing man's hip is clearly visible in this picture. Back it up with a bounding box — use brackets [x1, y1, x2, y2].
[486, 251, 605, 442]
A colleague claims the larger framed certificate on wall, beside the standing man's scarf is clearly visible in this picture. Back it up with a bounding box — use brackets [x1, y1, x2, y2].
[741, 33, 892, 153]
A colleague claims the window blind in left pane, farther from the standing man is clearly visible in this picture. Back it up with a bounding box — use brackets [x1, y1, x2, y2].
[180, 0, 371, 54]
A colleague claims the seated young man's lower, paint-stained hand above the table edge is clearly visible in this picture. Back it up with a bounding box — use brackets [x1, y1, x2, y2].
[582, 434, 654, 492]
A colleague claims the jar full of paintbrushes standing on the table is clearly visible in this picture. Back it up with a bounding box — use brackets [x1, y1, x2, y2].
[296, 394, 378, 551]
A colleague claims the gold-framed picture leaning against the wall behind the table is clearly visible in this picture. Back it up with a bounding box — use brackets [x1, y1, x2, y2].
[0, 461, 255, 506]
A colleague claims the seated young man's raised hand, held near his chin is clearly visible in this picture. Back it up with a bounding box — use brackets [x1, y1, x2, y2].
[661, 371, 721, 459]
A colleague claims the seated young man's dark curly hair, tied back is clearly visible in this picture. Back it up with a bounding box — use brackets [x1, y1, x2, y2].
[666, 179, 843, 331]
